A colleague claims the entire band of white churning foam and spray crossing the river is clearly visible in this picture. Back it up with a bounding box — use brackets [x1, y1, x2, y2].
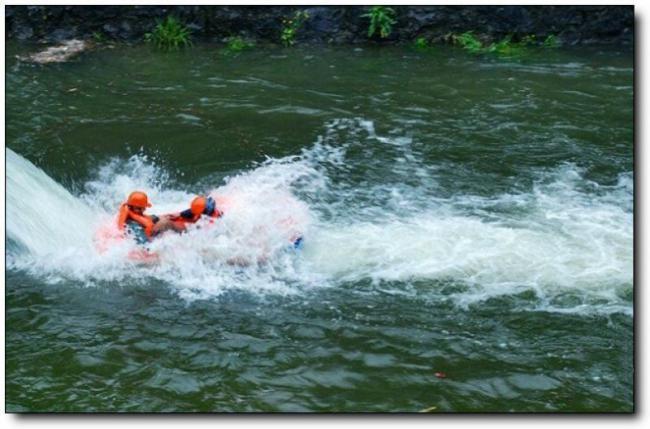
[7, 120, 633, 313]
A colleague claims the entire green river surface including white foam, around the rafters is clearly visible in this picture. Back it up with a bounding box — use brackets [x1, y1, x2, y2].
[5, 43, 634, 412]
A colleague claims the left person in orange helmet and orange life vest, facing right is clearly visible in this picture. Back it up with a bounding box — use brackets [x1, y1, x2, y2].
[117, 191, 184, 244]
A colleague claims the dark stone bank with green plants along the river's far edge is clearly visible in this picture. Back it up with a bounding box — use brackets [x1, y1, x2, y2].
[5, 5, 634, 45]
